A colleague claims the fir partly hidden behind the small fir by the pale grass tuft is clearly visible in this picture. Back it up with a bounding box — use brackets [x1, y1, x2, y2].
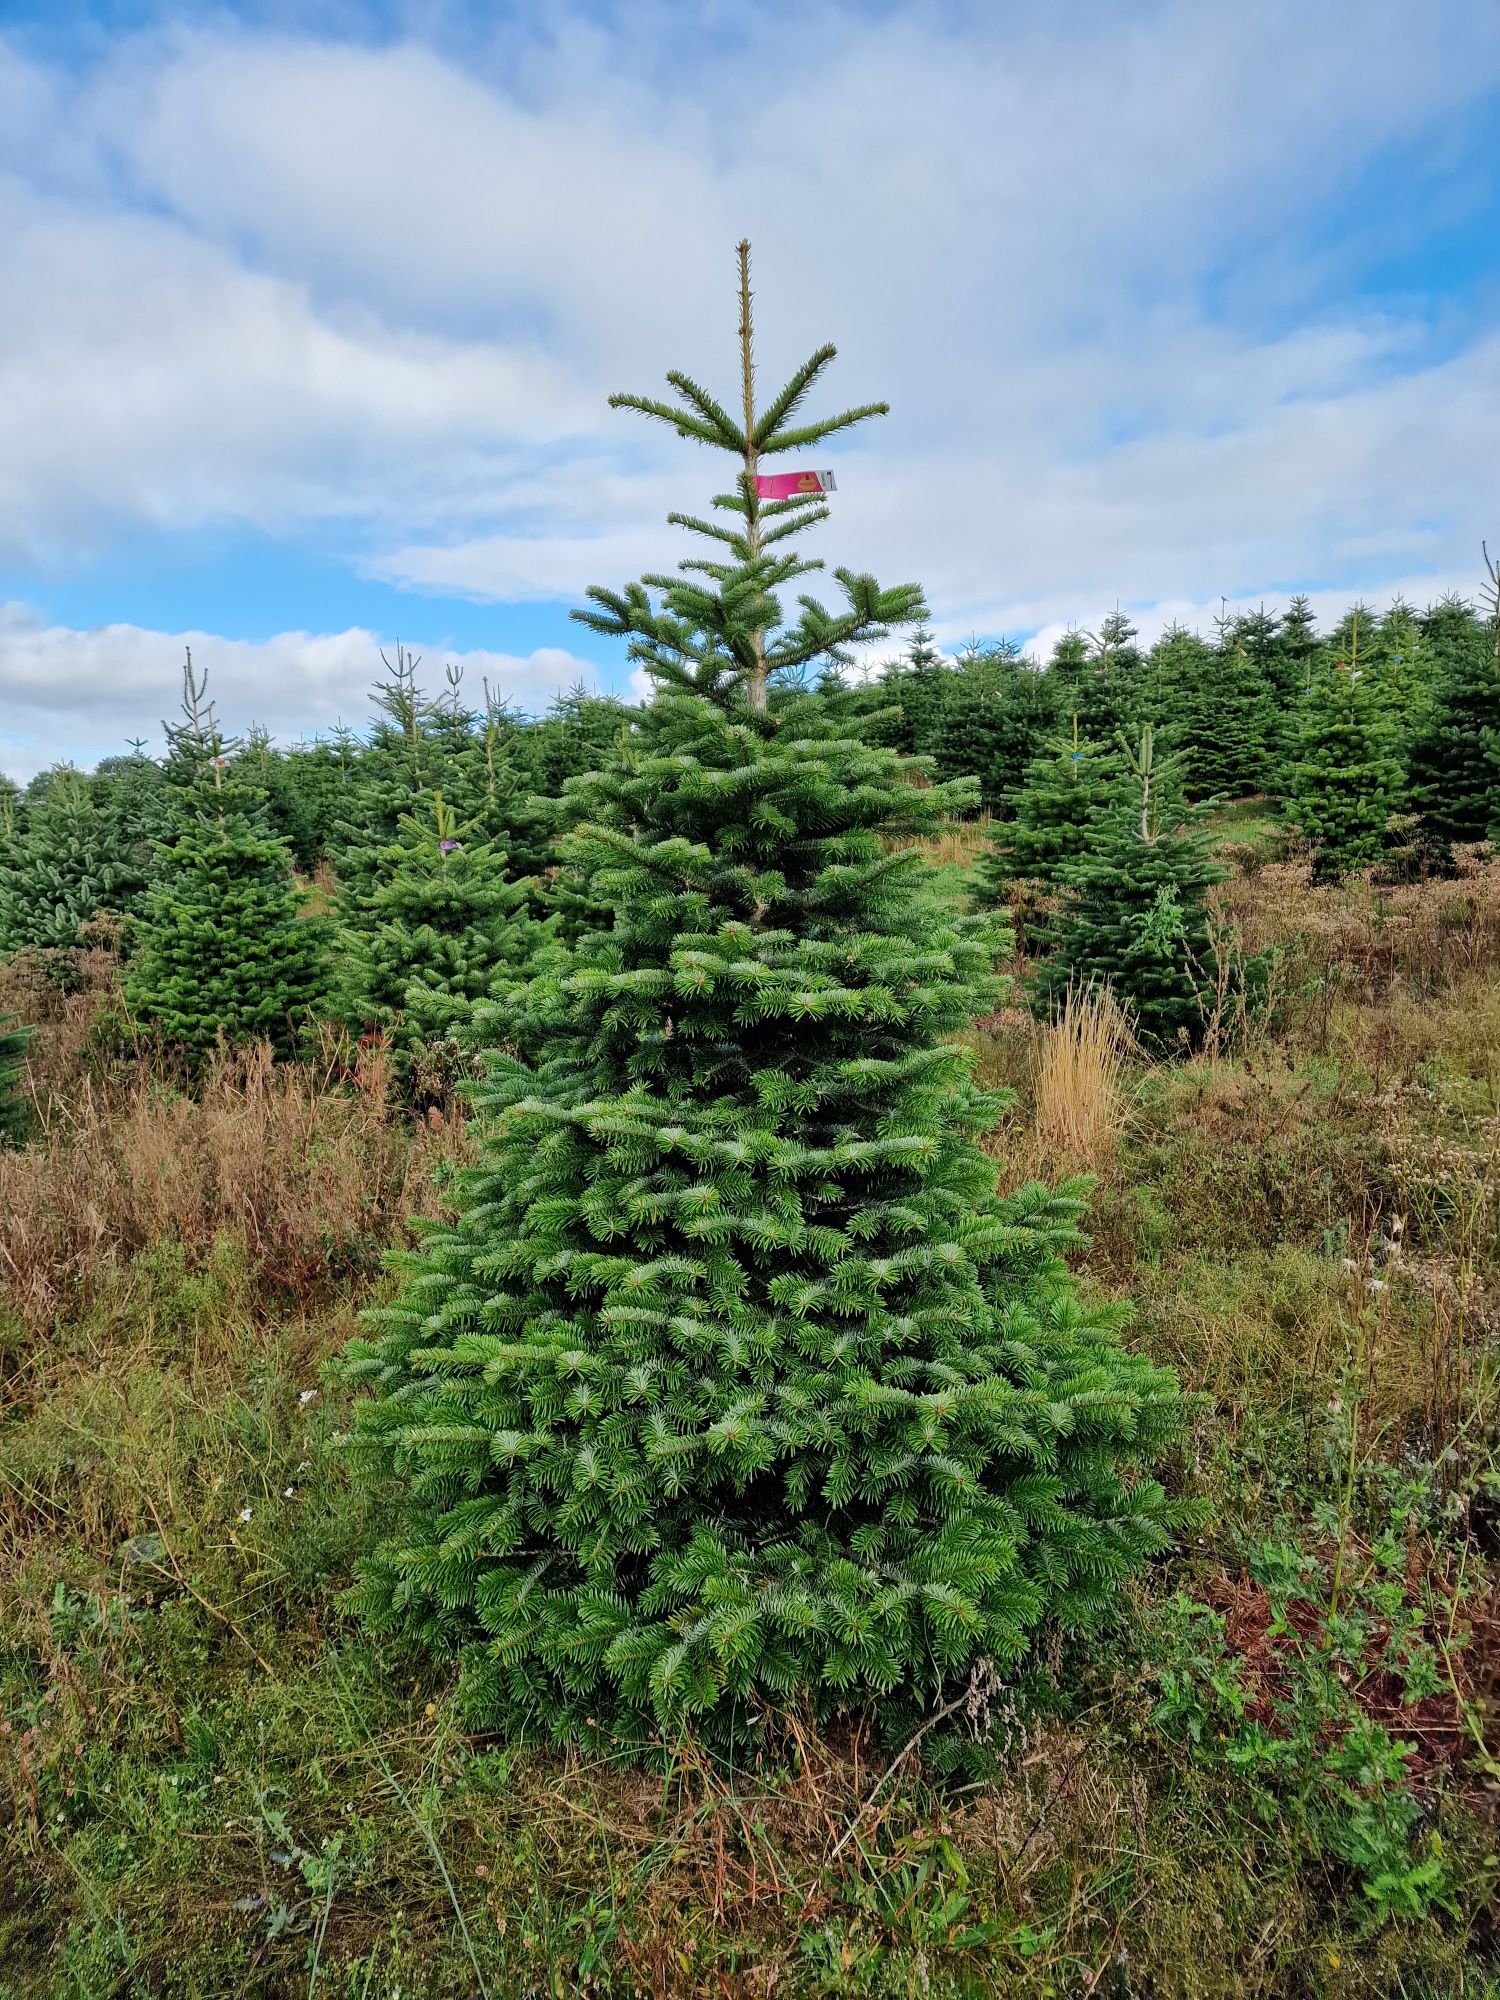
[976, 716, 1116, 952]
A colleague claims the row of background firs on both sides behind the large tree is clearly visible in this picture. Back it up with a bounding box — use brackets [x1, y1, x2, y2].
[0, 578, 1500, 1130]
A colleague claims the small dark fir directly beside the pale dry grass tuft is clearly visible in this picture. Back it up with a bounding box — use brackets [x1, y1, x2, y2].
[1036, 724, 1222, 1052]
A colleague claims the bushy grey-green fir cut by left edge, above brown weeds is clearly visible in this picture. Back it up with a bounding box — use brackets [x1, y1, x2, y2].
[0, 770, 146, 954]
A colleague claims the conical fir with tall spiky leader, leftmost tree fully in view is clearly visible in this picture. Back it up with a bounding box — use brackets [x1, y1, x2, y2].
[126, 656, 326, 1060]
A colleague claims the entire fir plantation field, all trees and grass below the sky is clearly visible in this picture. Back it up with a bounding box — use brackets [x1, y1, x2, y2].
[0, 244, 1500, 2000]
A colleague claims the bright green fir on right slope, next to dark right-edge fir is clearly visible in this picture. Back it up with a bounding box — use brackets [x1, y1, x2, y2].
[1286, 666, 1402, 882]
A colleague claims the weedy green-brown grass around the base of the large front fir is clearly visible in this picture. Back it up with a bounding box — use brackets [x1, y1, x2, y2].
[0, 852, 1500, 2000]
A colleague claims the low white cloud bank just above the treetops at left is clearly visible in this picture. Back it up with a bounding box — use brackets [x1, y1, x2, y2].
[0, 604, 598, 778]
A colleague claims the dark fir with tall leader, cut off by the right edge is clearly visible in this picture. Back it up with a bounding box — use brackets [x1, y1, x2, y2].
[1406, 548, 1500, 868]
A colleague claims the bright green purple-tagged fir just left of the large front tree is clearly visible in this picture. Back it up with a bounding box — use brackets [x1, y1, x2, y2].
[338, 792, 550, 1052]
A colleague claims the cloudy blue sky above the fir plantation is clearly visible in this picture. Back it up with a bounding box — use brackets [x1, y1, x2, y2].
[0, 0, 1500, 776]
